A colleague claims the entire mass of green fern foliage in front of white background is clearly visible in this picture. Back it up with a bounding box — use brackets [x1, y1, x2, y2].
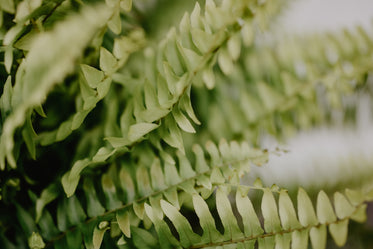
[0, 0, 373, 249]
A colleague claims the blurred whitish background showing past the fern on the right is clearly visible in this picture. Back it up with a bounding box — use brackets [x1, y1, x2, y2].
[247, 0, 373, 188]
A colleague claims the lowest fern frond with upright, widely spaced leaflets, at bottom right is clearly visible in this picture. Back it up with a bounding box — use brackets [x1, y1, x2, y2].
[145, 186, 372, 248]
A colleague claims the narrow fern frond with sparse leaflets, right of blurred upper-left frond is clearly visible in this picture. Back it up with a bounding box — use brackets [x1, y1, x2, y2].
[37, 30, 145, 146]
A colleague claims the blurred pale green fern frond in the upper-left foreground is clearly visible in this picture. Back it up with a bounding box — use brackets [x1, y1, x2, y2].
[0, 3, 109, 170]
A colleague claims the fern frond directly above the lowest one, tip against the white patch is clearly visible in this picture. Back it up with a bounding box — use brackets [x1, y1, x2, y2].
[37, 140, 268, 247]
